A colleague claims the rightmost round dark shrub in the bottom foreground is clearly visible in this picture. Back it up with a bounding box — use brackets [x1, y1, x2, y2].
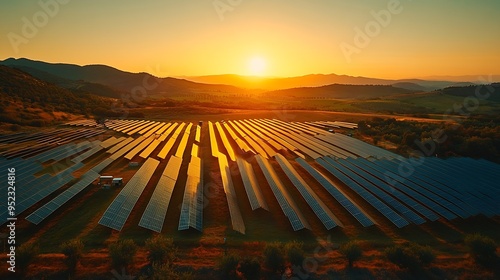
[465, 233, 498, 267]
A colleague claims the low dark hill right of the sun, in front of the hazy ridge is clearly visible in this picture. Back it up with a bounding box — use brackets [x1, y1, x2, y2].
[263, 84, 415, 99]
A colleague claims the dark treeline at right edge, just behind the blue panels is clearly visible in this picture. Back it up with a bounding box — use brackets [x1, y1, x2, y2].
[358, 116, 500, 163]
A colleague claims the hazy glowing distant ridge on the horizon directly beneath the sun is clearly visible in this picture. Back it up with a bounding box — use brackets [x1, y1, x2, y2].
[185, 74, 470, 91]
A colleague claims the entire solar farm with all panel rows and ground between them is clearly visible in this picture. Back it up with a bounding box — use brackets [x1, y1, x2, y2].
[0, 116, 500, 278]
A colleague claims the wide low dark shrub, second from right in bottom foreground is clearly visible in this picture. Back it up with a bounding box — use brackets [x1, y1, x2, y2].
[385, 244, 436, 271]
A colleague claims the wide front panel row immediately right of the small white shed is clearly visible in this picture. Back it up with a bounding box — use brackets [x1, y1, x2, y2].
[99, 158, 160, 231]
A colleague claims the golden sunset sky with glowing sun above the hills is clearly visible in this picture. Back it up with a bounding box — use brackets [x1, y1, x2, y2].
[0, 0, 500, 79]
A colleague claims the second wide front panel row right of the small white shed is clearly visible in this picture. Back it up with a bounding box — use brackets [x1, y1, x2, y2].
[139, 156, 182, 232]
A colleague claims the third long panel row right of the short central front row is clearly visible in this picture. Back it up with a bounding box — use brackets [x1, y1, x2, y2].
[295, 158, 375, 227]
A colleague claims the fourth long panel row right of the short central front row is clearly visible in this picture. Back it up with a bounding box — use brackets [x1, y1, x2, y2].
[316, 158, 409, 228]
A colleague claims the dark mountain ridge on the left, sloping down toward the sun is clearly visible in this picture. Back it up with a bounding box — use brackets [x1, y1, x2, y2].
[0, 58, 246, 97]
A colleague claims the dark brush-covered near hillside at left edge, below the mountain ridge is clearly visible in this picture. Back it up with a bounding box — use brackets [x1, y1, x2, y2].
[0, 65, 113, 126]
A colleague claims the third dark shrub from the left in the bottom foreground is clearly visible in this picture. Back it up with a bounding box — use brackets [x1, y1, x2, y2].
[146, 235, 177, 264]
